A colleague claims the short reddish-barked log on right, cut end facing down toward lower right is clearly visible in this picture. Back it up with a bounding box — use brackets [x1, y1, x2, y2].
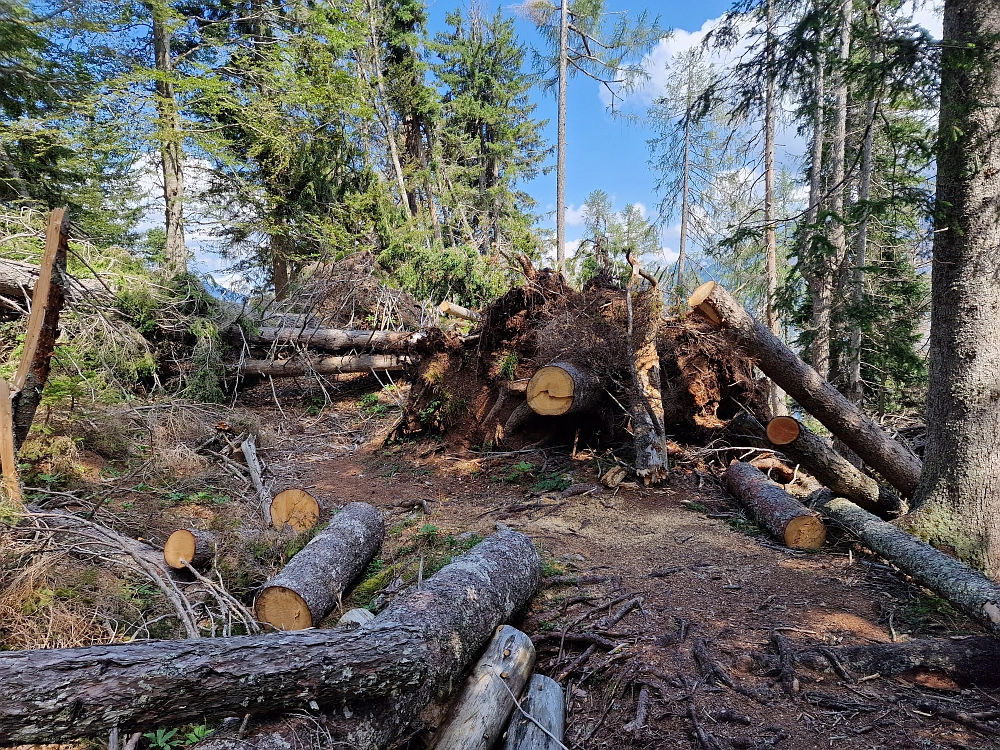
[726, 461, 826, 549]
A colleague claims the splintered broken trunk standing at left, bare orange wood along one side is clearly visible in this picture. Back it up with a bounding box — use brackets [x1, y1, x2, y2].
[11, 208, 69, 449]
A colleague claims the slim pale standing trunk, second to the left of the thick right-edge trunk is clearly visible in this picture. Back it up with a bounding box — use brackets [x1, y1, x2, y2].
[811, 0, 853, 378]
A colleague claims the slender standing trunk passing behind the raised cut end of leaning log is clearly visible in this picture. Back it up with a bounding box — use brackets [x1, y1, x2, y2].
[764, 0, 788, 417]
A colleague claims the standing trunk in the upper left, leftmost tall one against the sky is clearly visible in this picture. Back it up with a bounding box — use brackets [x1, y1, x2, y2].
[150, 4, 188, 274]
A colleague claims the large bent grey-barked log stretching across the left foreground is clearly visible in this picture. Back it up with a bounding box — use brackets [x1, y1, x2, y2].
[0, 531, 541, 748]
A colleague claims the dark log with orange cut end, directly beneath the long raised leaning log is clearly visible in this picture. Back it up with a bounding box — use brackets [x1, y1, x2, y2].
[766, 416, 902, 515]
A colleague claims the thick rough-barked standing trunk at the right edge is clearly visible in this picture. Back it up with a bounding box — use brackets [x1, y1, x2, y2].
[902, 0, 1000, 578]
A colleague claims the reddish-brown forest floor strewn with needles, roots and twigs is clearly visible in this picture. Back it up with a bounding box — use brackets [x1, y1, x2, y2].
[7, 383, 1000, 750]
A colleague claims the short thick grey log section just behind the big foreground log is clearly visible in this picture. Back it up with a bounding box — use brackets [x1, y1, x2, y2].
[254, 503, 385, 630]
